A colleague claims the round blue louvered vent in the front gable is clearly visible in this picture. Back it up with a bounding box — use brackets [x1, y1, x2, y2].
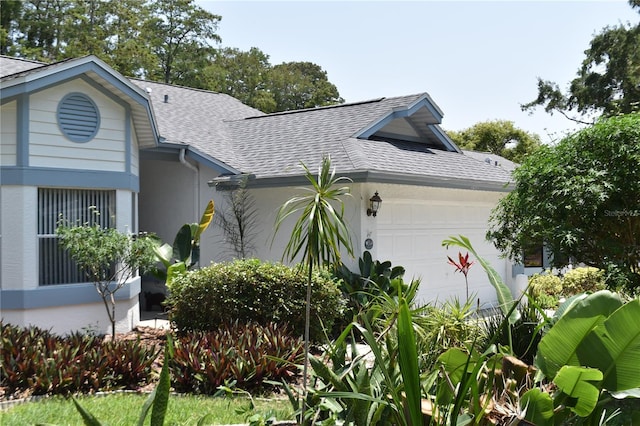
[58, 93, 100, 142]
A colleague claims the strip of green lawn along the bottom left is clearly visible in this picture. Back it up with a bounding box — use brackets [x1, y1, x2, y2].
[0, 393, 293, 426]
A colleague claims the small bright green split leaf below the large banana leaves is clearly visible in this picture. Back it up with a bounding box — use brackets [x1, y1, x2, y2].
[553, 365, 602, 417]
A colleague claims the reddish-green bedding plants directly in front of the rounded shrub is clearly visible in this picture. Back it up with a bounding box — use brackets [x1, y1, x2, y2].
[170, 323, 303, 395]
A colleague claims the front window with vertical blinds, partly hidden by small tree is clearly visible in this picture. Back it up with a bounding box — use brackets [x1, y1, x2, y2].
[38, 188, 116, 285]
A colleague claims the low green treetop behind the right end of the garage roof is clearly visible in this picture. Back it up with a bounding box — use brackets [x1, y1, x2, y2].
[447, 120, 540, 163]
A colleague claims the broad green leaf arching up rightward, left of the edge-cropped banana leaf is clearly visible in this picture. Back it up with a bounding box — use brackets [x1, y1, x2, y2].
[535, 290, 622, 378]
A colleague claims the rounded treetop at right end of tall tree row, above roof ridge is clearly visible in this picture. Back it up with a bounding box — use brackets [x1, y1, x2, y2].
[268, 62, 344, 111]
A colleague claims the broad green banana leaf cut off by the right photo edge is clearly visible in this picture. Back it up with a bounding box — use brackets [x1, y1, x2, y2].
[577, 299, 640, 391]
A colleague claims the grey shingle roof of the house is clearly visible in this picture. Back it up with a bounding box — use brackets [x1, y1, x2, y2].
[0, 57, 515, 187]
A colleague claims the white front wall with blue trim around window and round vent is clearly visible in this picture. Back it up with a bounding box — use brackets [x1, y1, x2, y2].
[0, 77, 146, 333]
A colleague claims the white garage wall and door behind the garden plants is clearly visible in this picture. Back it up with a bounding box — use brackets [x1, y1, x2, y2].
[208, 183, 512, 307]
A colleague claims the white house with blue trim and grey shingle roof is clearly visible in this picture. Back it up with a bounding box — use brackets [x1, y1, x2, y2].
[0, 56, 513, 332]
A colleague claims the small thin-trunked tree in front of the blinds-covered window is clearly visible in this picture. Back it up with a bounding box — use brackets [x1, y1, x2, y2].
[56, 210, 155, 339]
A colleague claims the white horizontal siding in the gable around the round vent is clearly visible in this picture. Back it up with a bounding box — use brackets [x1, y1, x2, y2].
[29, 79, 125, 172]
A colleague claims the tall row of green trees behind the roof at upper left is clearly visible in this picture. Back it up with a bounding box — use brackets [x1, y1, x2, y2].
[0, 0, 344, 113]
